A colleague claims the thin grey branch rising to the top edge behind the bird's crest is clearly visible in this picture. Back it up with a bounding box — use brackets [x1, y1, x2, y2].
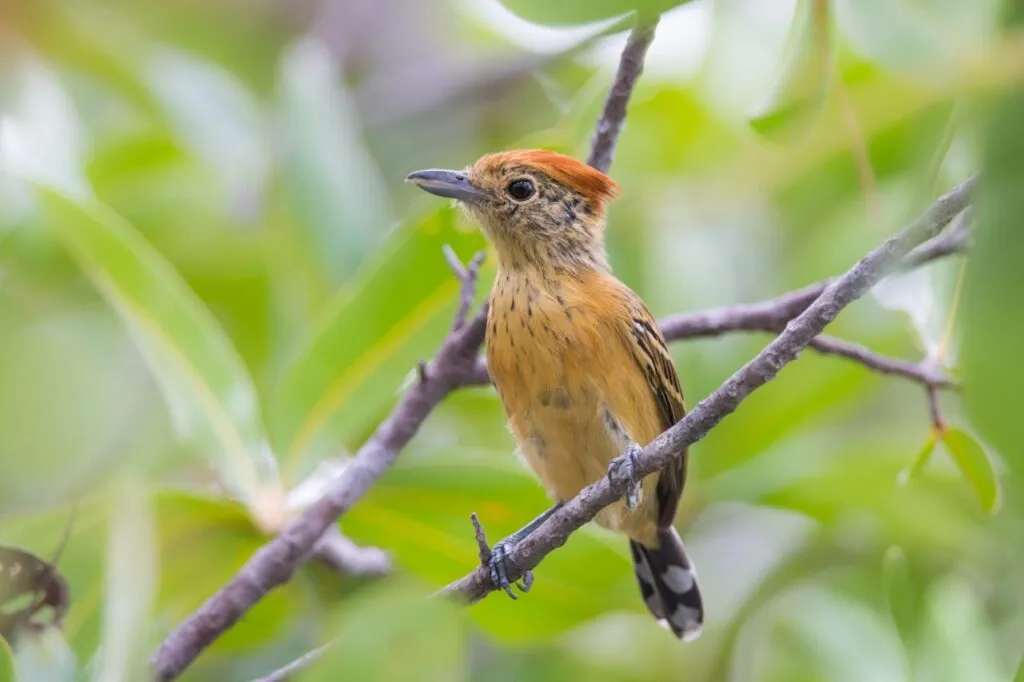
[587, 19, 657, 173]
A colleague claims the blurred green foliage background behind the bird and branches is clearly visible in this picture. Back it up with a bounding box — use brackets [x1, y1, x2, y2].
[0, 0, 1024, 682]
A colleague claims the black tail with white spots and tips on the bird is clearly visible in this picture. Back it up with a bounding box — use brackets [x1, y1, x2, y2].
[630, 527, 703, 641]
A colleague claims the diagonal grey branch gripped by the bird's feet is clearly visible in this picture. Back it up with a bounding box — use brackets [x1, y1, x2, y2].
[439, 178, 975, 602]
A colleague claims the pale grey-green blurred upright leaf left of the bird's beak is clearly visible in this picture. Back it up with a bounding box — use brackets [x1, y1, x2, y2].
[280, 38, 393, 289]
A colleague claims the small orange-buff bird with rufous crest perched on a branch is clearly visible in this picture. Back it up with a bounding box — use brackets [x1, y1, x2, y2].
[407, 150, 703, 640]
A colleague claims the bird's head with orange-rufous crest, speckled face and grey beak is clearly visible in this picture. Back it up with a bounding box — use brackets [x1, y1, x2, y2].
[407, 150, 617, 268]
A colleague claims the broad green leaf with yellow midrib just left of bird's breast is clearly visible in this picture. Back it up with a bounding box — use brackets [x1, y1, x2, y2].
[273, 209, 489, 482]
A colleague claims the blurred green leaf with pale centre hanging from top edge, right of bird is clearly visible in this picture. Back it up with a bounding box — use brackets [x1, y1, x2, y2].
[750, 0, 834, 140]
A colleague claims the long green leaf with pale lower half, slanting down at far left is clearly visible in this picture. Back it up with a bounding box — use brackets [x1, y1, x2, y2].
[39, 185, 282, 527]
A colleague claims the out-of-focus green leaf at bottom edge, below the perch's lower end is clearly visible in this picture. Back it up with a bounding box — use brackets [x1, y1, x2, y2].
[297, 582, 467, 682]
